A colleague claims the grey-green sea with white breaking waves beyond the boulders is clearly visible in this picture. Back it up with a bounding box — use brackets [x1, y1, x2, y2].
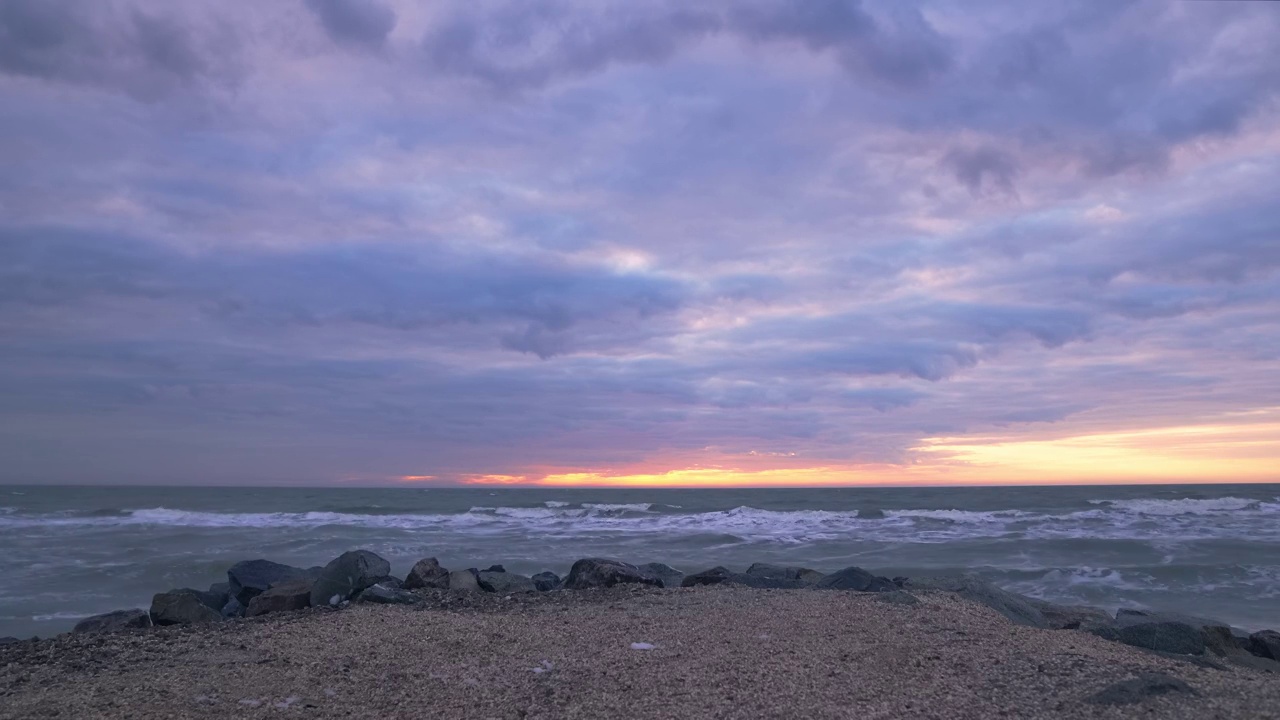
[0, 486, 1280, 637]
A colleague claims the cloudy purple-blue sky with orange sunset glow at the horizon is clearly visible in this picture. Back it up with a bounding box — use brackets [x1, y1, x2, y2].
[0, 0, 1280, 486]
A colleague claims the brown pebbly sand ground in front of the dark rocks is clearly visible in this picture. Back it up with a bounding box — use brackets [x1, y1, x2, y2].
[0, 587, 1280, 720]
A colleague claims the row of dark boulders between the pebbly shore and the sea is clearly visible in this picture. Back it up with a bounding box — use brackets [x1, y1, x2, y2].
[4, 550, 1280, 673]
